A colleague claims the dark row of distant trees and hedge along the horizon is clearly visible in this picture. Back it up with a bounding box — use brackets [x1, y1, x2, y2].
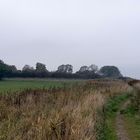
[0, 60, 122, 79]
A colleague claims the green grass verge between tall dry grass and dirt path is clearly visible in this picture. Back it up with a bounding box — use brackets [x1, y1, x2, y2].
[98, 93, 129, 140]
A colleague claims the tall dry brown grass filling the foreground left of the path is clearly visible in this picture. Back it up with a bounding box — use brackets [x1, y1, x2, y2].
[0, 81, 130, 140]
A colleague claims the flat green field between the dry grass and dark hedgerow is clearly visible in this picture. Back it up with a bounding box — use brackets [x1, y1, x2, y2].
[0, 79, 82, 93]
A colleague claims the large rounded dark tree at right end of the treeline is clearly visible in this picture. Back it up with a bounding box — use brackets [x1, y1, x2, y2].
[100, 66, 122, 78]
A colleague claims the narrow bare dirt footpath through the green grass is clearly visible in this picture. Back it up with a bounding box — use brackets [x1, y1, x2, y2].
[116, 101, 130, 140]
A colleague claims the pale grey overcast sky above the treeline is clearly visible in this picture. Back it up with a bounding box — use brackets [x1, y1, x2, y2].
[0, 0, 140, 78]
